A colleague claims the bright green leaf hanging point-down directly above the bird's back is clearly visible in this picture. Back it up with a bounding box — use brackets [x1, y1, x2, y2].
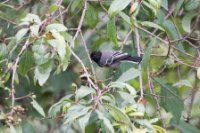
[107, 19, 118, 46]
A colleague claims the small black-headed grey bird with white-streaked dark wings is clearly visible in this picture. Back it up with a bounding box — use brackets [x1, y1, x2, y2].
[90, 51, 142, 68]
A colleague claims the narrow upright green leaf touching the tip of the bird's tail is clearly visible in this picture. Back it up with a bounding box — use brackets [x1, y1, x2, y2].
[141, 38, 156, 71]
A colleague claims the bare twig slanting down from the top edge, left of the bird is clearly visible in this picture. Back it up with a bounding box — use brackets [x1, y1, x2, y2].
[73, 0, 88, 41]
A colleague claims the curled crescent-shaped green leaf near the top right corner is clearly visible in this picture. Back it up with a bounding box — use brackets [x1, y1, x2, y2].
[182, 12, 198, 33]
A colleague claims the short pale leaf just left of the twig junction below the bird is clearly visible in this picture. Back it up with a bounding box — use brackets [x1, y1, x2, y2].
[76, 86, 95, 99]
